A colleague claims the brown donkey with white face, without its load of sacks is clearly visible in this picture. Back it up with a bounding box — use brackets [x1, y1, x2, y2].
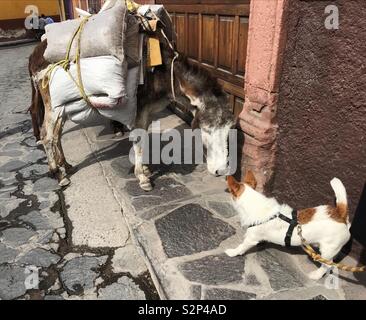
[29, 29, 235, 191]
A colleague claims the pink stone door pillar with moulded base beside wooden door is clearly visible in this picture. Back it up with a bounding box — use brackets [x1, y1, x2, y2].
[239, 0, 288, 189]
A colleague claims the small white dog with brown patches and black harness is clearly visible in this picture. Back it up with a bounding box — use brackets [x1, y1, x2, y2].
[225, 171, 351, 280]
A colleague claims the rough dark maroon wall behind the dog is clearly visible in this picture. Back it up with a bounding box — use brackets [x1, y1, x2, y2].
[271, 0, 366, 255]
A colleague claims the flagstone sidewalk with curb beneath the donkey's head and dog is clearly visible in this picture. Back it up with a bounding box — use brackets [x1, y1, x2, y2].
[65, 112, 366, 299]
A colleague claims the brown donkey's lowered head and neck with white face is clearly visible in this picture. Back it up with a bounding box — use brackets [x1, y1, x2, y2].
[176, 59, 235, 176]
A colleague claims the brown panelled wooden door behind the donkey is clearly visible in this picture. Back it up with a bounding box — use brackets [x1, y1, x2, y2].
[156, 0, 250, 115]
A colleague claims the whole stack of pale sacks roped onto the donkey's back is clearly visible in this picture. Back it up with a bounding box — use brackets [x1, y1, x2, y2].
[43, 0, 173, 128]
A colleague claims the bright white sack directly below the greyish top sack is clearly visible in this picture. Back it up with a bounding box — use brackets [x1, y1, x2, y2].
[49, 56, 126, 108]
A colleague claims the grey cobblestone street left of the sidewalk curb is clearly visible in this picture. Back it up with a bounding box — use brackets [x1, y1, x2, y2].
[0, 46, 158, 300]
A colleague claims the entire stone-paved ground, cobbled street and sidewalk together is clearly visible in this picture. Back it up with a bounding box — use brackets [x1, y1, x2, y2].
[0, 45, 366, 300]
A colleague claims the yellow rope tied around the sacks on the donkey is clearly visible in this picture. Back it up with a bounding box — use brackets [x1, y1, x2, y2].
[42, 17, 93, 107]
